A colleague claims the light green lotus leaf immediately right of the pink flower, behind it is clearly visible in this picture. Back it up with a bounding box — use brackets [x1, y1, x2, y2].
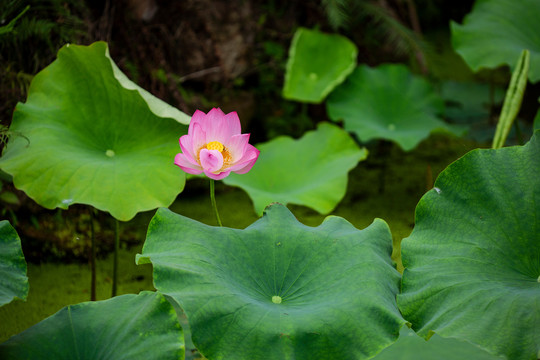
[223, 123, 367, 214]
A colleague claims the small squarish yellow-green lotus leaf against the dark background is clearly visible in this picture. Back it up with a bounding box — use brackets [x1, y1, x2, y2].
[283, 28, 358, 103]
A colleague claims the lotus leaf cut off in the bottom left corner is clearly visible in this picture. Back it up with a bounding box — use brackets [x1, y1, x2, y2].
[0, 292, 184, 360]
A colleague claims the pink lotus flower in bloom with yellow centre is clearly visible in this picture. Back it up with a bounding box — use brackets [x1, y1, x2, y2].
[174, 108, 259, 180]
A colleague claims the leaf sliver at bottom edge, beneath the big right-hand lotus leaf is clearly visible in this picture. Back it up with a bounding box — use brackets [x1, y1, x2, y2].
[373, 326, 503, 360]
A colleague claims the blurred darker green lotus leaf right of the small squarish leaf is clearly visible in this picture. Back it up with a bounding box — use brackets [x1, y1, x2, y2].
[326, 64, 456, 151]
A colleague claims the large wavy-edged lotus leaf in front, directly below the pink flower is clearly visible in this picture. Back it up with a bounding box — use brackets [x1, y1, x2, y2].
[137, 204, 405, 360]
